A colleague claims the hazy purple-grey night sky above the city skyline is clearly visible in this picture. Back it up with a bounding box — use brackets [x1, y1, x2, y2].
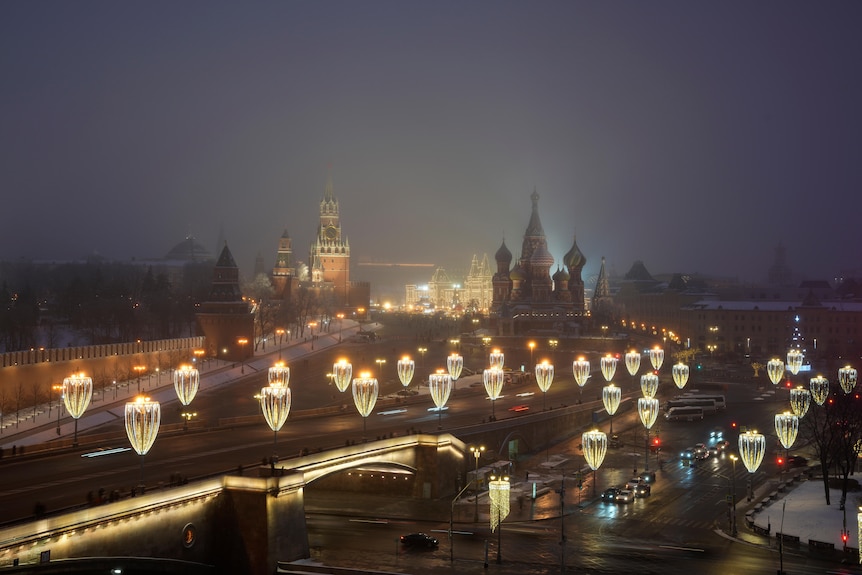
[0, 0, 862, 289]
